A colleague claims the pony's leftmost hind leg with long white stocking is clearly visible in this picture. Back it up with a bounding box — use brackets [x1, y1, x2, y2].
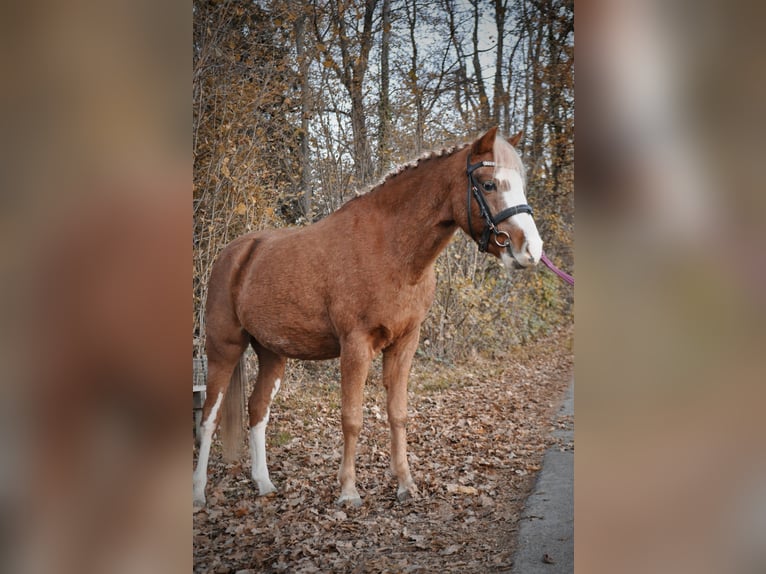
[194, 327, 248, 507]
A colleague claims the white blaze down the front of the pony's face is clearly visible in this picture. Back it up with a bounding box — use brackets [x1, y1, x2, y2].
[494, 141, 543, 269]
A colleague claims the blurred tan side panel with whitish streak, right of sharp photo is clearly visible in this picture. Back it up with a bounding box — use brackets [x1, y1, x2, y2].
[575, 0, 766, 574]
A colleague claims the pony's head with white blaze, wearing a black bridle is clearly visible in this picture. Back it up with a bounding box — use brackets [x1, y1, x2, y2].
[458, 128, 543, 269]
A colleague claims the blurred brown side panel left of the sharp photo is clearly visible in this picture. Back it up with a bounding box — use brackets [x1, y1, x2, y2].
[0, 2, 191, 573]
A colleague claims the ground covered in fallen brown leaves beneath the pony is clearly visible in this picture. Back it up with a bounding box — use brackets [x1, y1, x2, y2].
[193, 329, 574, 573]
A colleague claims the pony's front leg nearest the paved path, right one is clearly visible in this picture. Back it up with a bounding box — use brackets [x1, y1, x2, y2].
[383, 326, 420, 501]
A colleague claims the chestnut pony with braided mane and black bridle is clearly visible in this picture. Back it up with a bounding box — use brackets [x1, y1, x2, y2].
[194, 128, 542, 506]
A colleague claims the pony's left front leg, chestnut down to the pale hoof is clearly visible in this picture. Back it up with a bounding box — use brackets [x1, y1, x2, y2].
[337, 337, 372, 506]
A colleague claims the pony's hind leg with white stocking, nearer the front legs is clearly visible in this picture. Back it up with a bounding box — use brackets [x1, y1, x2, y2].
[247, 341, 285, 496]
